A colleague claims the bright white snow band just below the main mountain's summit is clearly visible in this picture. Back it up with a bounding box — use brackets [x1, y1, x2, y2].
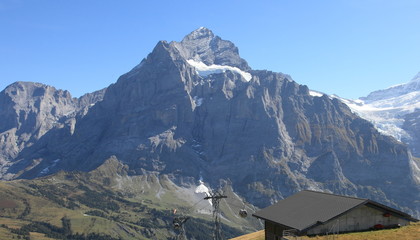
[187, 59, 252, 82]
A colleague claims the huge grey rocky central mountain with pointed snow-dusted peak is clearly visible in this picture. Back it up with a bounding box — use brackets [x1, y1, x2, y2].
[0, 28, 420, 218]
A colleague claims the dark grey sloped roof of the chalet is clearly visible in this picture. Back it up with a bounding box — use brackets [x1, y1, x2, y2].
[253, 190, 413, 231]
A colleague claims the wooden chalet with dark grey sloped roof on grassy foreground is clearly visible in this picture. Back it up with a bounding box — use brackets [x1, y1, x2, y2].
[253, 190, 418, 240]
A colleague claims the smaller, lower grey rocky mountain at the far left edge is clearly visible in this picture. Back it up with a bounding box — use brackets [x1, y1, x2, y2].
[0, 82, 105, 176]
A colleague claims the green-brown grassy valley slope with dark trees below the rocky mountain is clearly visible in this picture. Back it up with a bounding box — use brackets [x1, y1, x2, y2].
[0, 158, 255, 239]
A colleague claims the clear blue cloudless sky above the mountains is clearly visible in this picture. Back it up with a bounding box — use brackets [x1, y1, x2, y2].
[0, 0, 420, 98]
